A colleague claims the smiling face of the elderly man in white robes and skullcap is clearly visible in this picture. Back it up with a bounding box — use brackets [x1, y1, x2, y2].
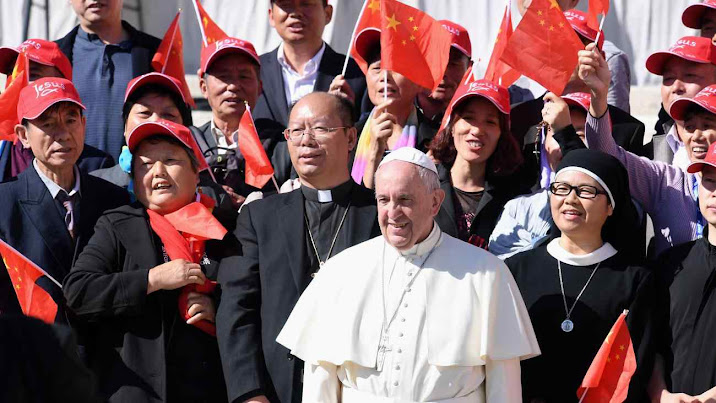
[375, 161, 445, 250]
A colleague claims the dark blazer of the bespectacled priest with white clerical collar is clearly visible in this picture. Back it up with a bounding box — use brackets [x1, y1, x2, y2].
[216, 185, 380, 403]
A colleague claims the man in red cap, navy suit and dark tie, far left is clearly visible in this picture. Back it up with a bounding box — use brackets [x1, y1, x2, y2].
[0, 78, 128, 322]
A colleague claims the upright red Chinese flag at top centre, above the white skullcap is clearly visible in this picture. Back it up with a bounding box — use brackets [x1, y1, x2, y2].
[380, 0, 452, 90]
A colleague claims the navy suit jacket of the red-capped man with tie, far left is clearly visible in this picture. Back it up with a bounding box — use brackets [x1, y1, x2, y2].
[0, 167, 129, 321]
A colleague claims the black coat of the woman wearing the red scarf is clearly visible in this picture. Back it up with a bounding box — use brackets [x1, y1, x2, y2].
[64, 203, 239, 403]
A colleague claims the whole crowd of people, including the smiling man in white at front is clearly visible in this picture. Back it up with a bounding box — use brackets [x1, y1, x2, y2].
[0, 0, 716, 403]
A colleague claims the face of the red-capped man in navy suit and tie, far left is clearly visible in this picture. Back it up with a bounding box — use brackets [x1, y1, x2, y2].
[15, 102, 85, 171]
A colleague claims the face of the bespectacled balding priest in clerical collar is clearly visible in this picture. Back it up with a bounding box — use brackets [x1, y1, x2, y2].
[287, 93, 356, 183]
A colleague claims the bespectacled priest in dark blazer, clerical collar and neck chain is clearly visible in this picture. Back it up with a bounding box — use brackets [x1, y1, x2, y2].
[216, 92, 380, 402]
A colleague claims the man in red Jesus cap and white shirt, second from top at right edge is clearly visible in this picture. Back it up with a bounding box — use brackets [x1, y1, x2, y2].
[646, 36, 716, 169]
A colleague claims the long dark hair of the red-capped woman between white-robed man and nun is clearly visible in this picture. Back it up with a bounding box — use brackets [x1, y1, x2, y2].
[428, 98, 522, 177]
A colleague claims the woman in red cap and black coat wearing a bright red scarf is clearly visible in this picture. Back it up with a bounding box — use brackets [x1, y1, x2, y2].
[64, 120, 232, 403]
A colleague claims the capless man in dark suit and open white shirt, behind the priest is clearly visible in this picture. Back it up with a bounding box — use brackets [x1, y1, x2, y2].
[254, 0, 365, 127]
